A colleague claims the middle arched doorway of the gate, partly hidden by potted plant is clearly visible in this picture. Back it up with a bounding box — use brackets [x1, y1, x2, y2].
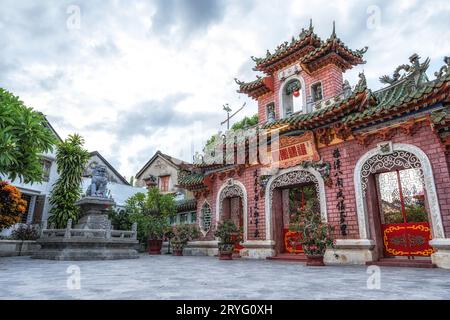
[265, 167, 327, 254]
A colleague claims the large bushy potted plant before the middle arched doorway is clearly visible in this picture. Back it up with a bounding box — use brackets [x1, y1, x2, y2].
[289, 189, 334, 266]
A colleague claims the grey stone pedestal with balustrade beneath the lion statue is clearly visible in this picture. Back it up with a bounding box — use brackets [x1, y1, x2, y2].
[32, 197, 139, 260]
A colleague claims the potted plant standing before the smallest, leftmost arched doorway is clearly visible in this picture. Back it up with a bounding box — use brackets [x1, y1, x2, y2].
[214, 220, 242, 260]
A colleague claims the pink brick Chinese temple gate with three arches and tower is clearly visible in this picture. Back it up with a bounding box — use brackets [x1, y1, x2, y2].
[179, 23, 450, 268]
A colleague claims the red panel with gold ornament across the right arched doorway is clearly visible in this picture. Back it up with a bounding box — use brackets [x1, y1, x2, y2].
[381, 222, 434, 257]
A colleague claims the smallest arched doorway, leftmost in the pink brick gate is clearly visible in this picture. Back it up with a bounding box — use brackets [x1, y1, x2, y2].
[216, 179, 247, 253]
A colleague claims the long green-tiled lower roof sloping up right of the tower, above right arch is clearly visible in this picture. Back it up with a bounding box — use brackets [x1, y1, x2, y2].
[265, 55, 450, 131]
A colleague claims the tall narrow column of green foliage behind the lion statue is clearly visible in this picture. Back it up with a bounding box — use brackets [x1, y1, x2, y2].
[49, 134, 90, 228]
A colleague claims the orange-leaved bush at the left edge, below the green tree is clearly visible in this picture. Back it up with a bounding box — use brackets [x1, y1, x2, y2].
[0, 181, 27, 231]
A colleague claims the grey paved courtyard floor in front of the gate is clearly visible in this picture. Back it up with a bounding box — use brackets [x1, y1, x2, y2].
[0, 255, 450, 300]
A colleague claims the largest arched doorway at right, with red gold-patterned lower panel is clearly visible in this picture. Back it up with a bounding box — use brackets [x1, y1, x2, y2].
[354, 142, 443, 259]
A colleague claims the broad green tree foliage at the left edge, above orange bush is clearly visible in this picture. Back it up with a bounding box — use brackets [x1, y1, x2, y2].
[0, 88, 56, 183]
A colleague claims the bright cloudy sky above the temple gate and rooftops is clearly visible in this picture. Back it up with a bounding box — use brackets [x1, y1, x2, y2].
[0, 0, 450, 177]
